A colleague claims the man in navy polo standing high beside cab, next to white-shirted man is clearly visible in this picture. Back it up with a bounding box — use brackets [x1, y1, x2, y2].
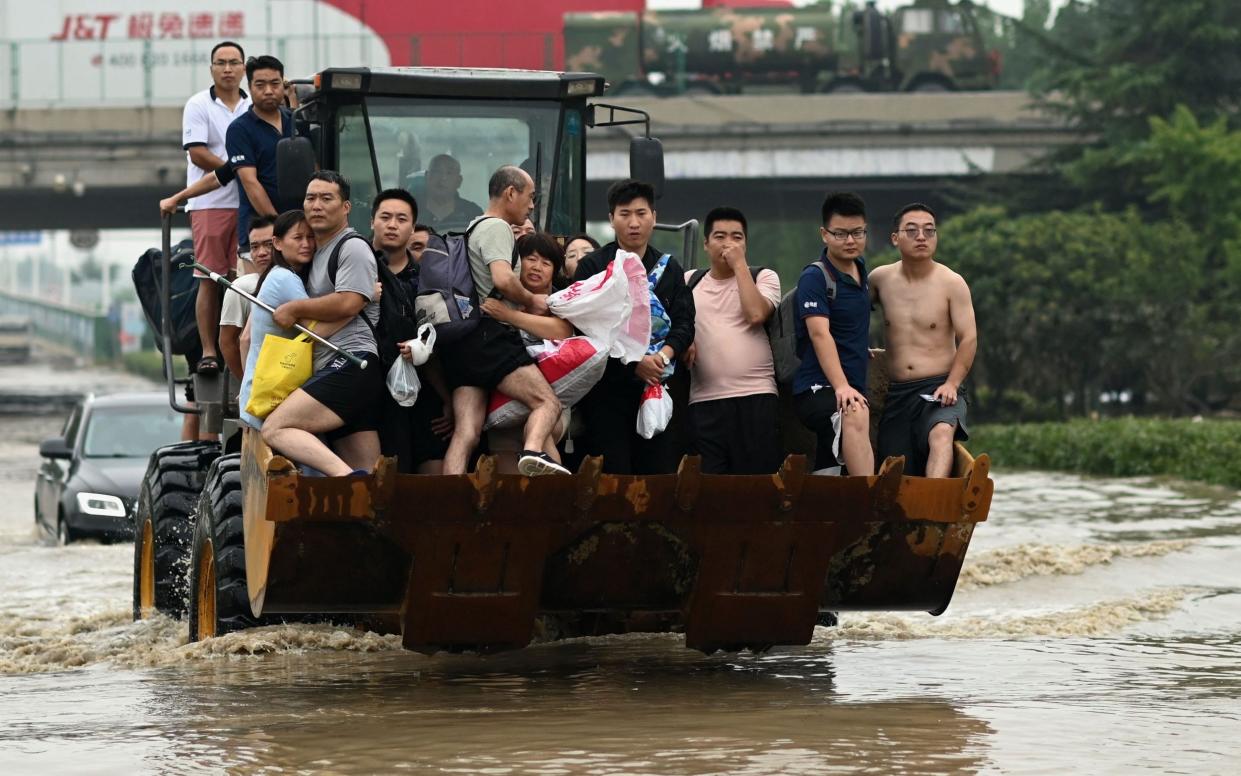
[225, 55, 302, 250]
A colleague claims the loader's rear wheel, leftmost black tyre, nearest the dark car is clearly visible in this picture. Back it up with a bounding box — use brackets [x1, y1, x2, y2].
[134, 442, 220, 620]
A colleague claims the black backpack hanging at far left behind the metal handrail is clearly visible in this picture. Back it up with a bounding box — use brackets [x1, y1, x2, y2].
[130, 240, 202, 355]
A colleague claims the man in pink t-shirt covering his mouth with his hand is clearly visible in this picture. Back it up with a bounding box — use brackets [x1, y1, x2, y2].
[685, 207, 783, 474]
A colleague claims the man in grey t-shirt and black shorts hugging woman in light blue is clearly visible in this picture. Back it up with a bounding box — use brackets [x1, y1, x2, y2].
[263, 170, 386, 477]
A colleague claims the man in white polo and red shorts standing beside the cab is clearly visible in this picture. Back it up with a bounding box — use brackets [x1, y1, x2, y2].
[181, 41, 251, 375]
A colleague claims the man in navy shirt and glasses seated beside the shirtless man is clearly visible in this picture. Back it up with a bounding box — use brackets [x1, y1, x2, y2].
[793, 194, 875, 476]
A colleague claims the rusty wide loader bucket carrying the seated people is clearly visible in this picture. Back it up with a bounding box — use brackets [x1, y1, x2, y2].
[242, 432, 993, 652]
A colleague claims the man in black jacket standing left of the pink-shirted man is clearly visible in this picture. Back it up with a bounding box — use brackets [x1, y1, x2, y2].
[573, 180, 694, 474]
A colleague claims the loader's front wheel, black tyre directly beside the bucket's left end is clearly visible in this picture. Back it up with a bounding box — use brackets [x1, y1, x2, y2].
[190, 454, 259, 641]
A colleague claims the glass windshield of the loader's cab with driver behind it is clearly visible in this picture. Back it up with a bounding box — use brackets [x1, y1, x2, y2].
[336, 97, 583, 235]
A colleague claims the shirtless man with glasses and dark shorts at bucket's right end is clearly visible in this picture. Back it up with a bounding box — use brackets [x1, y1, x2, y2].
[870, 202, 978, 477]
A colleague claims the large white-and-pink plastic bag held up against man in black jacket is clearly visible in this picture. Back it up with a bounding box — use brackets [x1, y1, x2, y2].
[547, 251, 650, 364]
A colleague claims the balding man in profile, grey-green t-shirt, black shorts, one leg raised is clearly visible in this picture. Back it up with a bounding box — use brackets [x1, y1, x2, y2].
[439, 165, 568, 477]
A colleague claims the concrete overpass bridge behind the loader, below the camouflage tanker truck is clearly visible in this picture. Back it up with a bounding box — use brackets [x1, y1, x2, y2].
[0, 92, 1080, 230]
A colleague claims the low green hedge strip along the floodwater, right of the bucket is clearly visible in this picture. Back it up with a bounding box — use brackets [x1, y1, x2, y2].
[969, 417, 1241, 488]
